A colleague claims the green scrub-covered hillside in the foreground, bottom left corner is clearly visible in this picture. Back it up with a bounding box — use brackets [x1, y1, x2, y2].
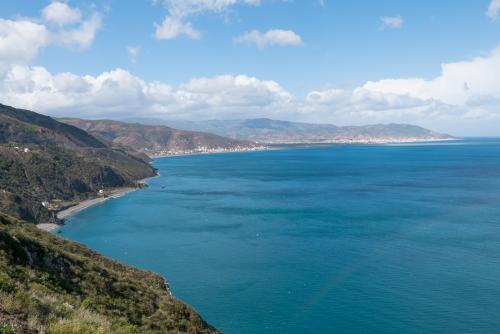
[0, 214, 217, 334]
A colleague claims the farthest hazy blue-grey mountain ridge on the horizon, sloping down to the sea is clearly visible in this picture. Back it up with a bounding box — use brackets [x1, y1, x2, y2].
[159, 118, 453, 144]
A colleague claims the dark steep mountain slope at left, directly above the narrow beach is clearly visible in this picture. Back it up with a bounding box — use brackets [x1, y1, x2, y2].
[0, 105, 156, 223]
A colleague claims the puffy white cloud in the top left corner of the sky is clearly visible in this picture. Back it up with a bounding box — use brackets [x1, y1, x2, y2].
[0, 2, 101, 72]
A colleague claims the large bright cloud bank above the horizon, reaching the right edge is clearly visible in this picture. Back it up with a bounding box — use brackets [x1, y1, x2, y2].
[301, 47, 500, 134]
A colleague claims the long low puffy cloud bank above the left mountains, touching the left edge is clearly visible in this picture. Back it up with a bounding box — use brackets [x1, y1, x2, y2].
[0, 66, 293, 118]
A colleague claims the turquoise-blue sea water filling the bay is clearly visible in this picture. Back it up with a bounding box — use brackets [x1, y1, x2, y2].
[62, 139, 500, 333]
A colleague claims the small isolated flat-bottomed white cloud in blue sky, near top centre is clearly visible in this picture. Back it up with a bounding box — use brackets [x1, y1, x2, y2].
[234, 29, 303, 48]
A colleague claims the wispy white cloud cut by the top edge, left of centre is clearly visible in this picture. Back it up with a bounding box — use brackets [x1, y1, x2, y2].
[154, 0, 260, 39]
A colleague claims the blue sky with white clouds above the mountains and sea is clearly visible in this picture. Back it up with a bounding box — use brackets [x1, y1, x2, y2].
[0, 0, 500, 136]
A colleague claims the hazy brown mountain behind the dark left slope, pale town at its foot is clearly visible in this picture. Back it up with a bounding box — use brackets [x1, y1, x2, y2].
[60, 118, 258, 156]
